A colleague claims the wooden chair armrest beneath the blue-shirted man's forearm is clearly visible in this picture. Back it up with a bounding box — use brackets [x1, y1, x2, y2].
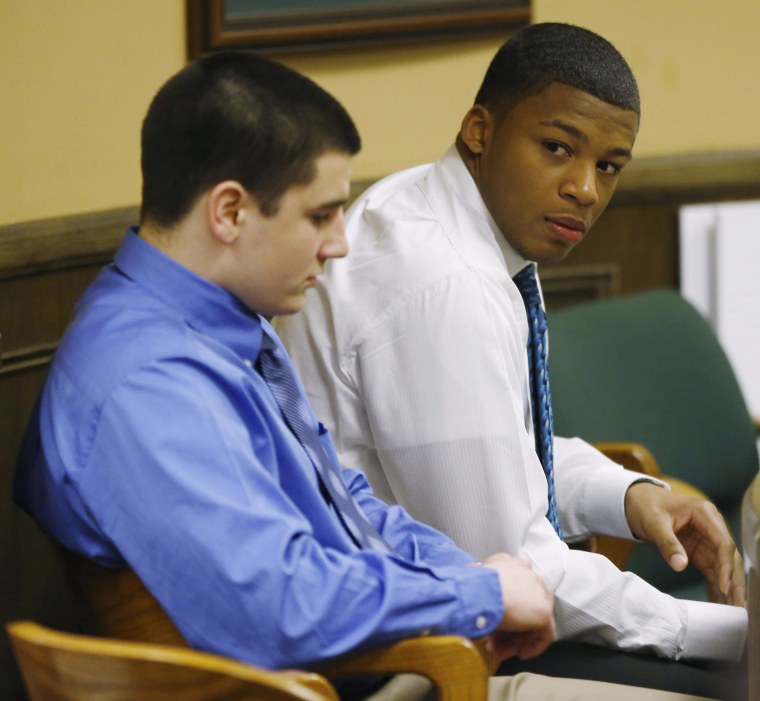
[318, 635, 488, 701]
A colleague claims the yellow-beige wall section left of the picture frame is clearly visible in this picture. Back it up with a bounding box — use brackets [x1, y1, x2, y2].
[0, 0, 184, 224]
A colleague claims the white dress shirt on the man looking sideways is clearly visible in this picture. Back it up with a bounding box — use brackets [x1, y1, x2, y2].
[278, 147, 747, 660]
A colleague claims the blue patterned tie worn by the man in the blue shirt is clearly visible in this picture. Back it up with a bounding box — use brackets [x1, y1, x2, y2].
[258, 331, 391, 553]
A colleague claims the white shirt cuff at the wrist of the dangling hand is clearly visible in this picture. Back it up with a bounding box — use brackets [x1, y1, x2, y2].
[586, 462, 669, 540]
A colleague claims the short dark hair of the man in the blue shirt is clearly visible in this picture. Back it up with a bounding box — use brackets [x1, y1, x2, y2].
[140, 51, 361, 227]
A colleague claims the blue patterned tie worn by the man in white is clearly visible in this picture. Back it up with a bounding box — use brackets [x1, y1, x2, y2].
[513, 265, 562, 538]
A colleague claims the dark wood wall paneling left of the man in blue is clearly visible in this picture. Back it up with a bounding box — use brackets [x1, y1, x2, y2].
[0, 208, 137, 701]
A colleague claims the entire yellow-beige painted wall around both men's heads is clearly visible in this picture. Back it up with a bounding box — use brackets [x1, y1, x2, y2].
[0, 0, 760, 225]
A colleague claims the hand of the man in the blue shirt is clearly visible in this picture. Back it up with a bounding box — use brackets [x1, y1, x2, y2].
[483, 553, 557, 660]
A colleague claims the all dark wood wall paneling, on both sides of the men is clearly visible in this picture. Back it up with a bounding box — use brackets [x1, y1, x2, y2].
[0, 153, 760, 701]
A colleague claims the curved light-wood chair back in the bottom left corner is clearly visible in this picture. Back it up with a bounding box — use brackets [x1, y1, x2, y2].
[7, 621, 338, 701]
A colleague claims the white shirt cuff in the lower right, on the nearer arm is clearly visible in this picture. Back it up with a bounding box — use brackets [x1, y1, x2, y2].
[676, 599, 748, 662]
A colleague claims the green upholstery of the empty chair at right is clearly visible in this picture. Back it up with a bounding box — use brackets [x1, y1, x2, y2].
[549, 290, 758, 599]
